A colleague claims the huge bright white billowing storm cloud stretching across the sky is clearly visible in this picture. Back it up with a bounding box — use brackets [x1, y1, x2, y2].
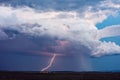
[0, 0, 120, 57]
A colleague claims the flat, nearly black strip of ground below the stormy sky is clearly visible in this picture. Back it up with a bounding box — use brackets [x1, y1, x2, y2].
[0, 71, 120, 80]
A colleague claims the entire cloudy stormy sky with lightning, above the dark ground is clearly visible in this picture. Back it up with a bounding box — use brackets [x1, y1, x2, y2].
[0, 0, 120, 71]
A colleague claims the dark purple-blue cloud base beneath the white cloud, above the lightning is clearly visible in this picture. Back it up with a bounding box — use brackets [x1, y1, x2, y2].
[0, 31, 90, 56]
